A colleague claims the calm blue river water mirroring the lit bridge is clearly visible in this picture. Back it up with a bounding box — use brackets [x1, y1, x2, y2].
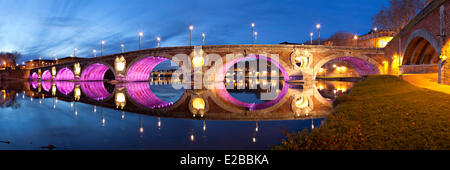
[0, 81, 352, 149]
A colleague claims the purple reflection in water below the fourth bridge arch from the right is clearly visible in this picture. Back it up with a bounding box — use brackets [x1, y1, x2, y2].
[81, 81, 111, 101]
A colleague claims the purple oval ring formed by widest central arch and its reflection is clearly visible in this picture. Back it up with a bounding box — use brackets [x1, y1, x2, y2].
[216, 55, 289, 110]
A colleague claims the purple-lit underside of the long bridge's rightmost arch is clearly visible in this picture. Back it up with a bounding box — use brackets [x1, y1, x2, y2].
[332, 57, 379, 75]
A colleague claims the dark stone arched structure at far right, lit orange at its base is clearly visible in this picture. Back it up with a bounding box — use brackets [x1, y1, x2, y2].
[384, 0, 450, 84]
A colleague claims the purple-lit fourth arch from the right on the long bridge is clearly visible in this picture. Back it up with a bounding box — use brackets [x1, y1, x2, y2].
[80, 63, 115, 81]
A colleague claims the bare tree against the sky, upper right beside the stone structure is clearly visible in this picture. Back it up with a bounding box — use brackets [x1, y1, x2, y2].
[372, 0, 433, 33]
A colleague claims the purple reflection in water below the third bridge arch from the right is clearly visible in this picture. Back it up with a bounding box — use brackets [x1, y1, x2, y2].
[126, 82, 173, 109]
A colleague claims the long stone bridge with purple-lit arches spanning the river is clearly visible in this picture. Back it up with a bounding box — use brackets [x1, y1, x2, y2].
[29, 45, 388, 81]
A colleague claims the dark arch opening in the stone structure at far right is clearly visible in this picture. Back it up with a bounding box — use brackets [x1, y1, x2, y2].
[402, 29, 441, 65]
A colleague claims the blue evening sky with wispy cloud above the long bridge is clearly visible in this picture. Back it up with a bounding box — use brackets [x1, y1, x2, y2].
[0, 0, 389, 61]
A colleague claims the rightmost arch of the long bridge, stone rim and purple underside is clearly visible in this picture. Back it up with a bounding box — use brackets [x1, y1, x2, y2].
[313, 55, 384, 79]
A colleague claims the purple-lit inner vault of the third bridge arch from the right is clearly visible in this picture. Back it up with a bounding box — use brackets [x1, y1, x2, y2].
[126, 57, 167, 81]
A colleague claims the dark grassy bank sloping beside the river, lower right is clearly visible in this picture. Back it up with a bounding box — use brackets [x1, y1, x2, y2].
[272, 76, 450, 150]
